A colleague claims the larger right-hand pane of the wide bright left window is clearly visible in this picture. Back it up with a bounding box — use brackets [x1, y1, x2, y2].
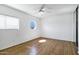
[6, 16, 19, 29]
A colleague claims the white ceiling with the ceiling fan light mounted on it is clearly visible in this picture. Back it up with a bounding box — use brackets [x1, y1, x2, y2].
[7, 4, 77, 18]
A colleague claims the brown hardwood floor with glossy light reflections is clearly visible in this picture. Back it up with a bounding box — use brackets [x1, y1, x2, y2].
[0, 38, 77, 55]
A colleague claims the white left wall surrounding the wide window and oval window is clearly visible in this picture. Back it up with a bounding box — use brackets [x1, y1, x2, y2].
[0, 5, 40, 50]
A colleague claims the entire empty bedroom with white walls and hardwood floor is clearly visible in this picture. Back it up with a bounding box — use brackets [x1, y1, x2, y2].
[0, 4, 79, 55]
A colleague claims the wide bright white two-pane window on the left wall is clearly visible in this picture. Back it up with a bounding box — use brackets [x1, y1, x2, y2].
[0, 15, 19, 29]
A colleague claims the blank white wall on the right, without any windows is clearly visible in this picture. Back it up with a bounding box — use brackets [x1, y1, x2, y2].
[41, 13, 75, 41]
